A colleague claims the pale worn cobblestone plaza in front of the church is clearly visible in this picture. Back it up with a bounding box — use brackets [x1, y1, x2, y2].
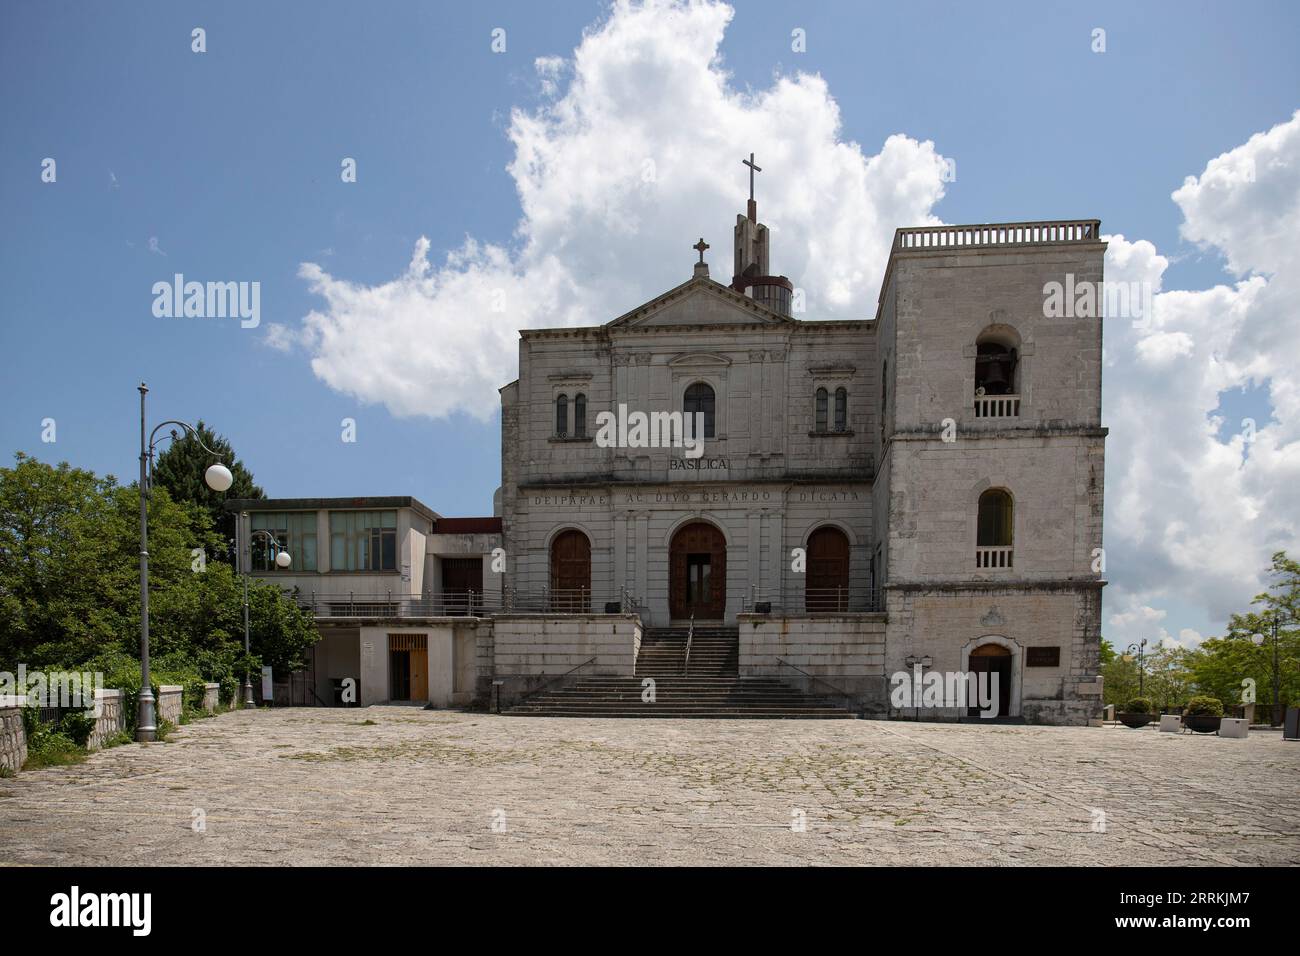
[0, 706, 1300, 866]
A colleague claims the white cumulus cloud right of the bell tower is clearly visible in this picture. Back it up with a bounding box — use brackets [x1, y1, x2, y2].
[1105, 113, 1300, 644]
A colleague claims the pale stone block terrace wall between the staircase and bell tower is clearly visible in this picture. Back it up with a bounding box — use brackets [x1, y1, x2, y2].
[738, 614, 885, 710]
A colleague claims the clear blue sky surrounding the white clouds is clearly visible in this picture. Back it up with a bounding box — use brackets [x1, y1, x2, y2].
[0, 1, 1300, 642]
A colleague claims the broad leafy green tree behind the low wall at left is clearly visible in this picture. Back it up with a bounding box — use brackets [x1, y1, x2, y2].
[0, 454, 317, 680]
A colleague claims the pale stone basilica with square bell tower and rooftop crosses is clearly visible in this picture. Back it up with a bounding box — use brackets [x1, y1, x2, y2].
[233, 162, 1106, 723]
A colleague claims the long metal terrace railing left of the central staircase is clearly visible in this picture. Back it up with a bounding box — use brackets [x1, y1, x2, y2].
[305, 588, 642, 619]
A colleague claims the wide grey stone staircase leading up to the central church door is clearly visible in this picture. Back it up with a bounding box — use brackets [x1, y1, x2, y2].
[507, 624, 855, 719]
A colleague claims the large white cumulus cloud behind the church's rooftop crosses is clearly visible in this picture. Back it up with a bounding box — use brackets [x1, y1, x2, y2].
[267, 0, 944, 419]
